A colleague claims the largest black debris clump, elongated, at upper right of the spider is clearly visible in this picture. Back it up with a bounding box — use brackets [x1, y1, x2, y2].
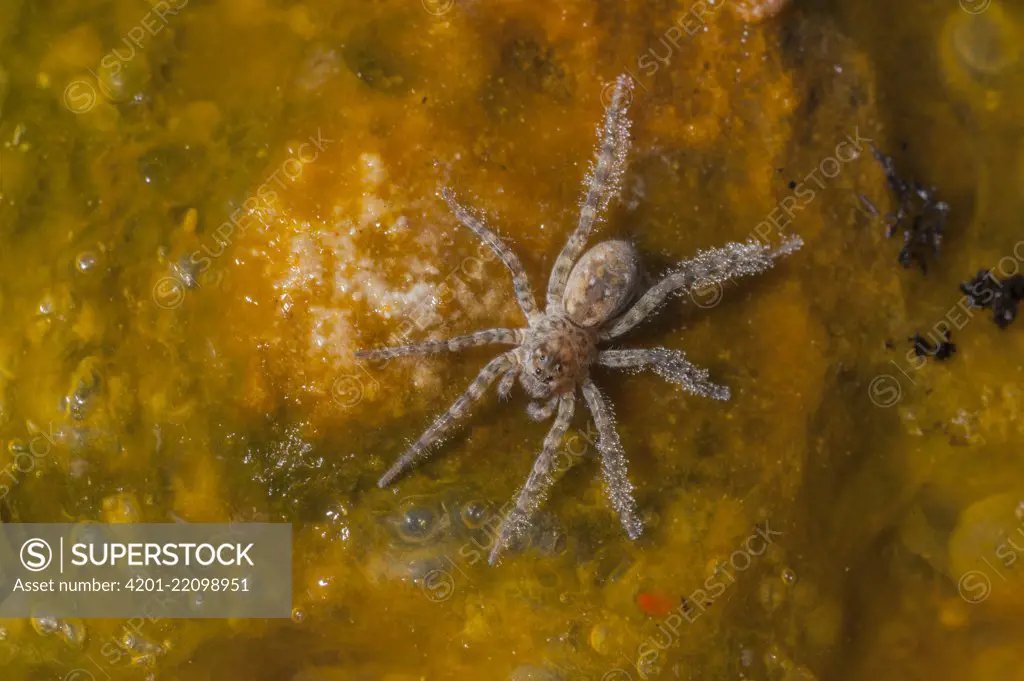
[871, 144, 949, 273]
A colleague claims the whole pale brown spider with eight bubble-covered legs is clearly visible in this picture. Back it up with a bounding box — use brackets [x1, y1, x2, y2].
[356, 76, 803, 562]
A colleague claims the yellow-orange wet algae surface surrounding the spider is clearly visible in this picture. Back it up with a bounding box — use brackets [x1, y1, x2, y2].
[0, 0, 1024, 681]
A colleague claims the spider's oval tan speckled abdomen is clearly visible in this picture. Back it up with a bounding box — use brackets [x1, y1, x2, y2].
[562, 241, 640, 329]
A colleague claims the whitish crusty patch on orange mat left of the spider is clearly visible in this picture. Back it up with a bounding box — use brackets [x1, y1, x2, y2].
[262, 153, 512, 372]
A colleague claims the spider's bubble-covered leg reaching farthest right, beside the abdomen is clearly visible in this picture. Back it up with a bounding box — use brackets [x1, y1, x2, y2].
[601, 237, 804, 341]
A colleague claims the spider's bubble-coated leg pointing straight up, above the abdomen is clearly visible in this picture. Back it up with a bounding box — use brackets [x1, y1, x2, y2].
[548, 74, 633, 310]
